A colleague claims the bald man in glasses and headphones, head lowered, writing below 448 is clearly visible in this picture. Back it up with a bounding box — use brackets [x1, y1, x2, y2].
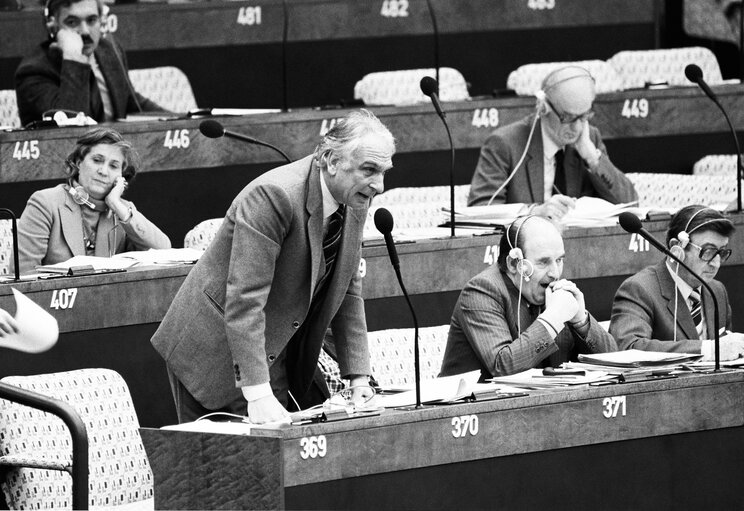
[468, 66, 638, 219]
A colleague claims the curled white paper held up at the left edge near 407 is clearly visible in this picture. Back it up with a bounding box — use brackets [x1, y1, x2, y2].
[0, 288, 59, 353]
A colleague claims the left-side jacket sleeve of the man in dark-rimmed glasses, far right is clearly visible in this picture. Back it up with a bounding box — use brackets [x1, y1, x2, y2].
[610, 277, 702, 353]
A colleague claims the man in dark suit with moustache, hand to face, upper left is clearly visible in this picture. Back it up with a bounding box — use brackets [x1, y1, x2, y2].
[15, 0, 164, 126]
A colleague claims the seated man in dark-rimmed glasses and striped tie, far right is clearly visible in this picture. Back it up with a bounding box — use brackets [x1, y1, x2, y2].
[610, 206, 744, 360]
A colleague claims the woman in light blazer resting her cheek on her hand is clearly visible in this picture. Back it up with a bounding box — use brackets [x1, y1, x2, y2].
[13, 128, 171, 272]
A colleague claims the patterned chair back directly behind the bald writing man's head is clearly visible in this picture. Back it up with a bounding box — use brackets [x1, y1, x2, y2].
[506, 60, 623, 96]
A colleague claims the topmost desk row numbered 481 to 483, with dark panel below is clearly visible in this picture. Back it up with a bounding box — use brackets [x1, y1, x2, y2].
[0, 0, 663, 107]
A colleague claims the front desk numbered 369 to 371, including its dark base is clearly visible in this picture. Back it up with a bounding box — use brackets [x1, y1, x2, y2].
[141, 372, 744, 509]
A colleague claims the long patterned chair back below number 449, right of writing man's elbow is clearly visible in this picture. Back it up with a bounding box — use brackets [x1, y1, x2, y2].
[625, 172, 736, 209]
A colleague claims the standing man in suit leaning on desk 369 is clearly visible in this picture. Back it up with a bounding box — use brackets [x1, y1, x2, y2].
[152, 110, 395, 423]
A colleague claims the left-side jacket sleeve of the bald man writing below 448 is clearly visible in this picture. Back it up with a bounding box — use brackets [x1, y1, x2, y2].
[468, 133, 512, 206]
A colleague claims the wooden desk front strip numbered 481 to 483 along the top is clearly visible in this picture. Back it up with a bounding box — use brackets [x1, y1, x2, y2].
[0, 0, 658, 58]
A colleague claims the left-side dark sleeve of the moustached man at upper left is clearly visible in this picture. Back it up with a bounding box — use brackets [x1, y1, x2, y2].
[15, 50, 93, 125]
